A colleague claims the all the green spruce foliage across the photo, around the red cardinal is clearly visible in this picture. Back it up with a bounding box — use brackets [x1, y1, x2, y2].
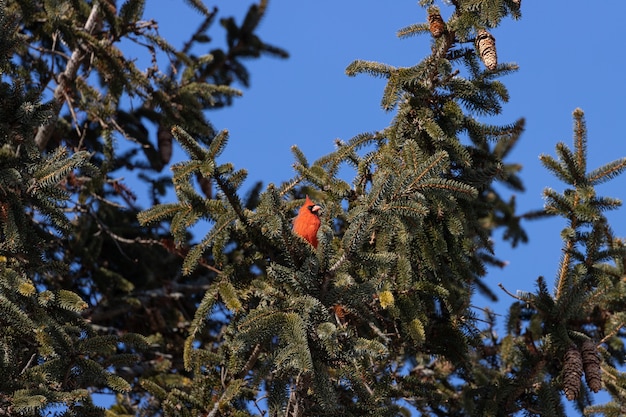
[0, 0, 626, 417]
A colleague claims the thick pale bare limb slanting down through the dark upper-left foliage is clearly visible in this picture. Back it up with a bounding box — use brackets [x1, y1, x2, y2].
[35, 1, 100, 150]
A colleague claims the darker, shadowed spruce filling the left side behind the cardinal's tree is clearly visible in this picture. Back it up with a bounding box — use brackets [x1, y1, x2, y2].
[0, 0, 287, 416]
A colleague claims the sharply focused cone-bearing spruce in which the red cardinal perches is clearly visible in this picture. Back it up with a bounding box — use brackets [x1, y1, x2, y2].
[140, 1, 626, 416]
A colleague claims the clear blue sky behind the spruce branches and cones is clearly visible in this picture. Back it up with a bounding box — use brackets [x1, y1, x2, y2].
[107, 0, 626, 410]
